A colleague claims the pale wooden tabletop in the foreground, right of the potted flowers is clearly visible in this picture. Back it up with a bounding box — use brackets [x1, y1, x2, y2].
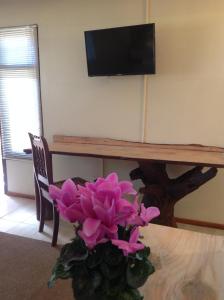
[141, 224, 224, 300]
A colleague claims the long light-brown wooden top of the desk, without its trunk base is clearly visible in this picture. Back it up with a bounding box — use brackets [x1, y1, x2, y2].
[49, 135, 224, 168]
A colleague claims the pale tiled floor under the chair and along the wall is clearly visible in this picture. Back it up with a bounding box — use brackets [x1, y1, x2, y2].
[0, 192, 224, 244]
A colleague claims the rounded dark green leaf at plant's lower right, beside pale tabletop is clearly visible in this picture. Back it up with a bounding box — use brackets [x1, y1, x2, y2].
[126, 260, 155, 288]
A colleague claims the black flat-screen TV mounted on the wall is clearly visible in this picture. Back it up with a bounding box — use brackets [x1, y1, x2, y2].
[85, 24, 155, 76]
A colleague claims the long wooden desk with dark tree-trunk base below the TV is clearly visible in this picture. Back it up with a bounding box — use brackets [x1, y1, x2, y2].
[49, 135, 224, 227]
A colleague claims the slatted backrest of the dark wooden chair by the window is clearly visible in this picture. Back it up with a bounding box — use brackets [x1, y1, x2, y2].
[29, 133, 53, 198]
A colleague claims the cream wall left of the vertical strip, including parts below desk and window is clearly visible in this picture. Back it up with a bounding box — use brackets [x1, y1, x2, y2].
[0, 0, 145, 193]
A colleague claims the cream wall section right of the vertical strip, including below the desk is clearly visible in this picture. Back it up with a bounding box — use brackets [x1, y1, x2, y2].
[147, 0, 224, 223]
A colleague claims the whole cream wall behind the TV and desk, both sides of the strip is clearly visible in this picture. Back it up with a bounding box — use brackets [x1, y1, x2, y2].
[0, 0, 224, 223]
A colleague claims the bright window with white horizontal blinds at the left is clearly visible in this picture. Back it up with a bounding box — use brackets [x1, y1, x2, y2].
[0, 25, 42, 158]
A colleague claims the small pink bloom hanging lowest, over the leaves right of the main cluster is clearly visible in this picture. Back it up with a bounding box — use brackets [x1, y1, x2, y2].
[111, 227, 145, 256]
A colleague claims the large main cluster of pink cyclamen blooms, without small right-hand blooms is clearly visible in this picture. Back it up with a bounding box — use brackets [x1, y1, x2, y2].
[49, 173, 137, 249]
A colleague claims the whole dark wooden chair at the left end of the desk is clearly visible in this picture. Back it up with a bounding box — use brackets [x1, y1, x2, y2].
[29, 133, 86, 246]
